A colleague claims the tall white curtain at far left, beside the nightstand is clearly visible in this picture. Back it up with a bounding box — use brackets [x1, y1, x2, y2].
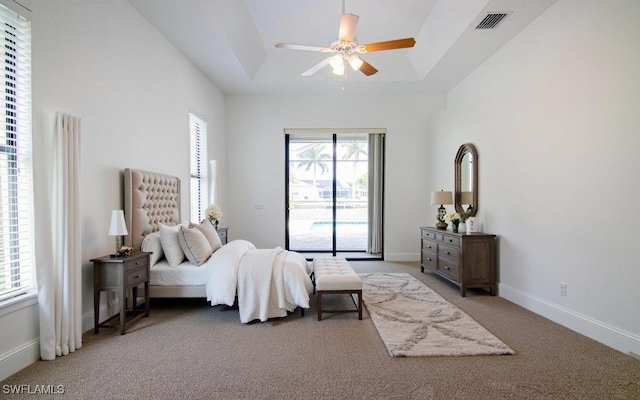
[37, 113, 82, 360]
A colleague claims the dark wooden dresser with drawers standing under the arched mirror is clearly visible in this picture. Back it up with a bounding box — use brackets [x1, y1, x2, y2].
[420, 226, 496, 296]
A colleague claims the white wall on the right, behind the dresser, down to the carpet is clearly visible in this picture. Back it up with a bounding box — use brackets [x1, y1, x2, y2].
[431, 0, 640, 354]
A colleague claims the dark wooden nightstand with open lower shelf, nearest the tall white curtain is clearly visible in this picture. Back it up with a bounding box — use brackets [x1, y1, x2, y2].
[91, 252, 151, 335]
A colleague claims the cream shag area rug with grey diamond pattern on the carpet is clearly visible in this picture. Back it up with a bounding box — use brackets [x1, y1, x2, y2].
[359, 273, 515, 357]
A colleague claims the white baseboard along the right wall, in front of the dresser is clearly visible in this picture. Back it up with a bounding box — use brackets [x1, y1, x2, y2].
[498, 284, 640, 355]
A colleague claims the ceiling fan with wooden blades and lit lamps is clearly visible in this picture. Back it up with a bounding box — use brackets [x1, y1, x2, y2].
[276, 0, 416, 76]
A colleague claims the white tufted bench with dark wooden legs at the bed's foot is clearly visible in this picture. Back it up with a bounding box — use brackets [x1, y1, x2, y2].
[313, 257, 362, 321]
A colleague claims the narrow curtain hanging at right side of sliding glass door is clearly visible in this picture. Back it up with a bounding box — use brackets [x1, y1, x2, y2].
[367, 133, 384, 254]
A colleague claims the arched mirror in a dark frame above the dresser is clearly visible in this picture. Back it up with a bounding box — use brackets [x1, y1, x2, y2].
[454, 143, 478, 217]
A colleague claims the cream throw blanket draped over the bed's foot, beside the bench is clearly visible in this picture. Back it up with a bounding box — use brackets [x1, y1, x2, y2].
[238, 247, 287, 323]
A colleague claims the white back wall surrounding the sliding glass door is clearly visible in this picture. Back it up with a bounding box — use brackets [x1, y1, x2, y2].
[225, 93, 444, 261]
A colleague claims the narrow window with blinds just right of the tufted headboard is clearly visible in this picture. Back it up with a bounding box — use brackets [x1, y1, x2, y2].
[189, 113, 207, 222]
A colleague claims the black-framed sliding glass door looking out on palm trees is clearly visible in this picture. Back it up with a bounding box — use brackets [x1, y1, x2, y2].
[286, 133, 381, 258]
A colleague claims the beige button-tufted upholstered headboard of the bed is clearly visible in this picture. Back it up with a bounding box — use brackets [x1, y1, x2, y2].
[124, 168, 180, 251]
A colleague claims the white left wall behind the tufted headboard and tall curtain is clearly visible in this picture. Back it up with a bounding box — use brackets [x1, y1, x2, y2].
[0, 0, 226, 379]
